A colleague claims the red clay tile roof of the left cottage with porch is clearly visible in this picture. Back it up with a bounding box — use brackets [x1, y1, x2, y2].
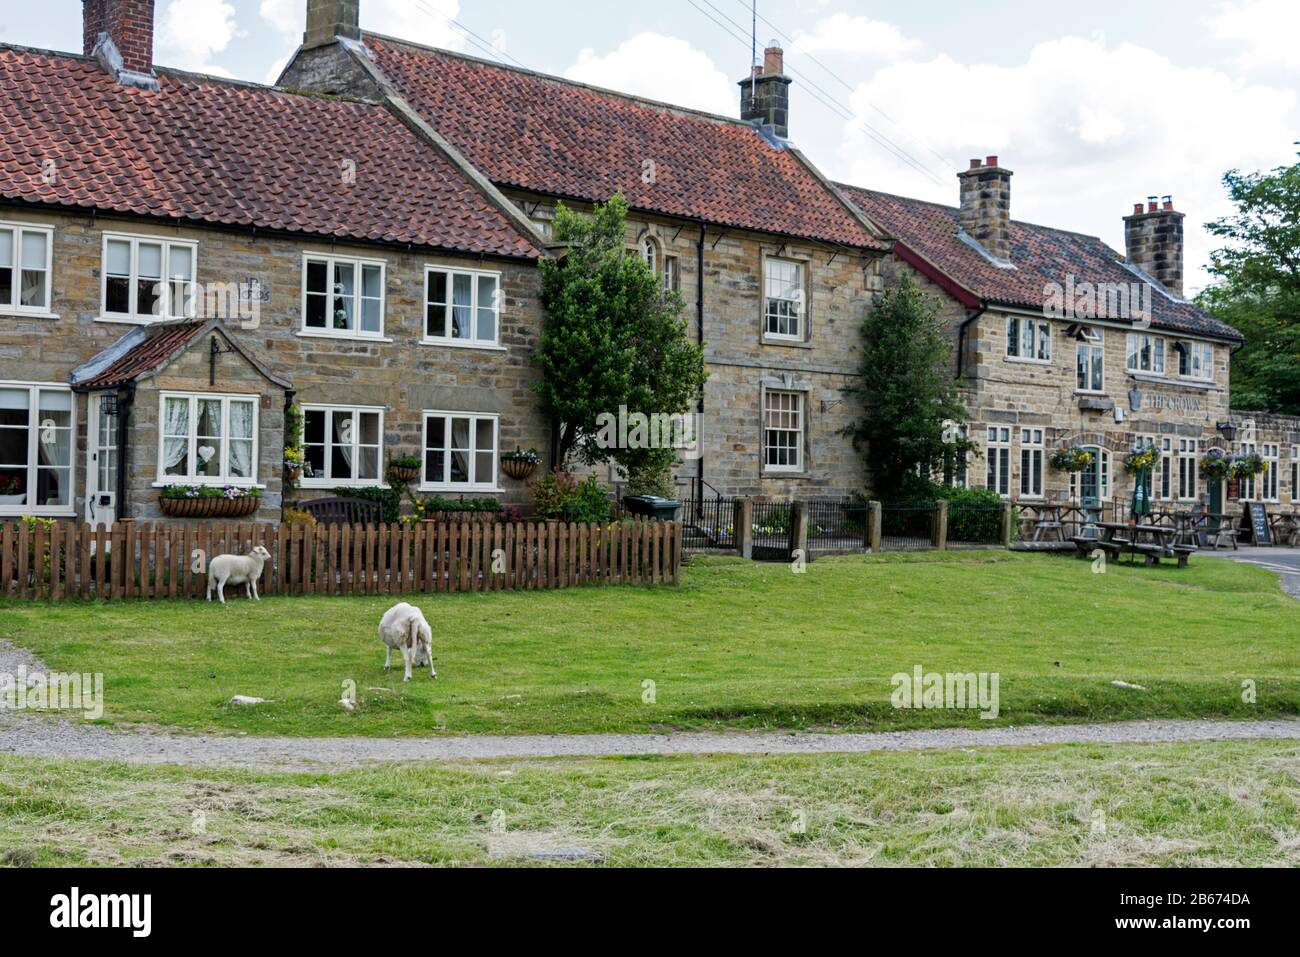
[0, 46, 540, 259]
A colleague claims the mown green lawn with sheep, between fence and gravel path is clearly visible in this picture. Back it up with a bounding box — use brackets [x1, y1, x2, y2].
[0, 551, 1300, 736]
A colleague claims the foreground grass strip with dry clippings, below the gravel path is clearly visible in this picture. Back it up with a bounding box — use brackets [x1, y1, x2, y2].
[0, 741, 1300, 867]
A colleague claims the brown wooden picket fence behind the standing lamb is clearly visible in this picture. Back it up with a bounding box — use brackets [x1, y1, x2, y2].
[0, 520, 681, 601]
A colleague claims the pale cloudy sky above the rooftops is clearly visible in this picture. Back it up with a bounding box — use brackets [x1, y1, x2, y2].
[0, 0, 1300, 294]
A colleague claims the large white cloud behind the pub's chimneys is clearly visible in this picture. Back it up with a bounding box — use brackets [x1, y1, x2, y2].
[839, 38, 1297, 290]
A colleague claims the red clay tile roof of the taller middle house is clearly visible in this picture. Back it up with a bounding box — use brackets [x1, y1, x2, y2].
[365, 35, 884, 250]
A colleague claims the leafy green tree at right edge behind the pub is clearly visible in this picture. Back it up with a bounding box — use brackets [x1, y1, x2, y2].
[1196, 150, 1300, 415]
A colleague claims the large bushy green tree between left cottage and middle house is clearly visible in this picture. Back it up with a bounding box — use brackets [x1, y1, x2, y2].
[536, 196, 707, 476]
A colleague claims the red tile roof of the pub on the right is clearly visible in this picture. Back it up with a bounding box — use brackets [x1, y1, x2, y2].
[840, 186, 1243, 342]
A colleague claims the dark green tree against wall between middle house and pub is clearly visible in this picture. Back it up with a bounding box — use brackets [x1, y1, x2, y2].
[844, 273, 971, 498]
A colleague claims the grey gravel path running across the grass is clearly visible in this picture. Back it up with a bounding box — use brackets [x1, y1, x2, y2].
[0, 641, 1300, 770]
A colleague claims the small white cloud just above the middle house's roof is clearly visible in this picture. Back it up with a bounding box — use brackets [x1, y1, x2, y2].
[564, 33, 740, 116]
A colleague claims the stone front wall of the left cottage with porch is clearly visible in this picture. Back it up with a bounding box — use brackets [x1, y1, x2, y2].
[0, 209, 550, 518]
